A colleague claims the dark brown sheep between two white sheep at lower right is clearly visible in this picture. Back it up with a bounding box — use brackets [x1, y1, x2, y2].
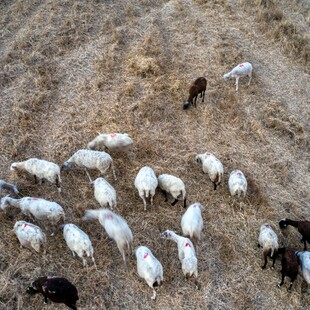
[278, 248, 298, 291]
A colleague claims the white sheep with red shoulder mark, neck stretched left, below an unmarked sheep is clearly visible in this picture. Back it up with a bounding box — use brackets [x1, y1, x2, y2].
[160, 230, 198, 278]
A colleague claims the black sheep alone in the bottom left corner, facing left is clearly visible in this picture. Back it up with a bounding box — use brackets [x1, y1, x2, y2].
[27, 277, 79, 310]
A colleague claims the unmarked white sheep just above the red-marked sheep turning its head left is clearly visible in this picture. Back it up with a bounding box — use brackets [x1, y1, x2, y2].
[181, 202, 203, 252]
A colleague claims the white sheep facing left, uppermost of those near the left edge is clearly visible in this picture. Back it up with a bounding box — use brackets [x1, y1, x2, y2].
[11, 158, 61, 192]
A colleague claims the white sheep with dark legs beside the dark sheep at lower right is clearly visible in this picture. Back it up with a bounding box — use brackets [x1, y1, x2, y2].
[258, 224, 279, 269]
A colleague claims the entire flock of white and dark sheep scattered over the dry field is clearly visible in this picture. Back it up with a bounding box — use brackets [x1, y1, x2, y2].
[0, 63, 310, 309]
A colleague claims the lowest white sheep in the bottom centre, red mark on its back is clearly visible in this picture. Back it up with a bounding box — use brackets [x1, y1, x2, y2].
[136, 246, 164, 299]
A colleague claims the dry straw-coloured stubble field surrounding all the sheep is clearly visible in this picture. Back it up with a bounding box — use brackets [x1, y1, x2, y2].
[0, 0, 310, 310]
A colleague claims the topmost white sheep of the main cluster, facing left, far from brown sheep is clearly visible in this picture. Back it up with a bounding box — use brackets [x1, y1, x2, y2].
[87, 133, 133, 153]
